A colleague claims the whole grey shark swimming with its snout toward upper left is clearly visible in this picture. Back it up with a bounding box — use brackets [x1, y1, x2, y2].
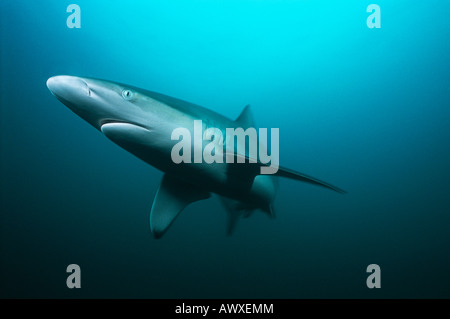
[47, 75, 345, 238]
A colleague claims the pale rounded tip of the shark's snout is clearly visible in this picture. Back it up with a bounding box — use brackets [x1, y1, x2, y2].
[47, 75, 90, 101]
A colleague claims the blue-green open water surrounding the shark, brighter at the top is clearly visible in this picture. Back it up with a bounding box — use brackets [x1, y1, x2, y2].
[0, 0, 450, 298]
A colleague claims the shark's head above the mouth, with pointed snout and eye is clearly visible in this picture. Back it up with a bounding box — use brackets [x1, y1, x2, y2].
[47, 75, 154, 130]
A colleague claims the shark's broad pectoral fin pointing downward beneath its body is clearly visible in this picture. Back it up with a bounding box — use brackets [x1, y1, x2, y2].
[150, 174, 211, 238]
